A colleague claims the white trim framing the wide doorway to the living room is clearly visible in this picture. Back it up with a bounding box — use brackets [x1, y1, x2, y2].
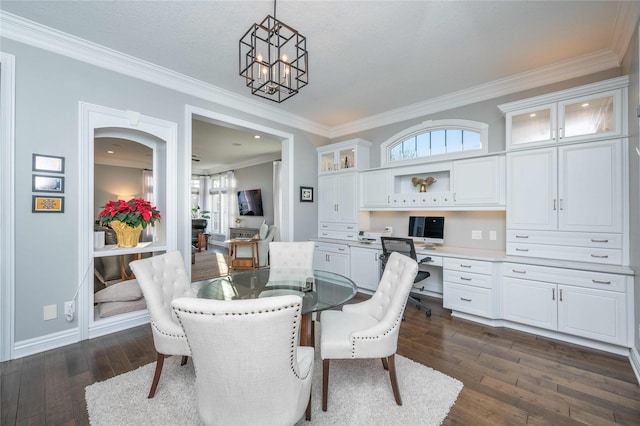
[180, 105, 294, 256]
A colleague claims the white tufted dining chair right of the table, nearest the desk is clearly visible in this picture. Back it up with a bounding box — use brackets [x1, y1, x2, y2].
[320, 253, 418, 411]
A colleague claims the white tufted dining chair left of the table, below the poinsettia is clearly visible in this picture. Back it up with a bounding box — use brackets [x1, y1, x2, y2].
[129, 251, 195, 398]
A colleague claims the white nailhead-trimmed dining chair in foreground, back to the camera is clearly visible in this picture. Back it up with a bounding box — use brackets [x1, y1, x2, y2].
[172, 295, 314, 426]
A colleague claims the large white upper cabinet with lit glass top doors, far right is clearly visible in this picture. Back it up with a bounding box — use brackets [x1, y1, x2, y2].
[500, 77, 628, 265]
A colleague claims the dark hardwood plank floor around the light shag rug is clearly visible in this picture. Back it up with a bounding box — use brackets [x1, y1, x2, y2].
[0, 294, 640, 426]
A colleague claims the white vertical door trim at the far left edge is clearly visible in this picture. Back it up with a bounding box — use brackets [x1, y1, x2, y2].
[0, 52, 16, 361]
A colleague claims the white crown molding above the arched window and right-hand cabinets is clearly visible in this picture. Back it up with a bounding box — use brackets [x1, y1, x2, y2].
[330, 49, 620, 138]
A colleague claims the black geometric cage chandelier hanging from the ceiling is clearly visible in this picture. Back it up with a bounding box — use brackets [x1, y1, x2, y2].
[240, 0, 309, 103]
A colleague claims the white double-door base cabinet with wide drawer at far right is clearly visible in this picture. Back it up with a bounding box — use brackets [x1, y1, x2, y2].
[502, 263, 632, 346]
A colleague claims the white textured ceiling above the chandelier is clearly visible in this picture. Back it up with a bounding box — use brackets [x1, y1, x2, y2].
[0, 0, 638, 171]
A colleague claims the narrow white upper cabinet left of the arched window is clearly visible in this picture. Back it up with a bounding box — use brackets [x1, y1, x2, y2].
[317, 139, 371, 240]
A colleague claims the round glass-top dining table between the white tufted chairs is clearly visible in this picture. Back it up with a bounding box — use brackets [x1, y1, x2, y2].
[192, 269, 357, 346]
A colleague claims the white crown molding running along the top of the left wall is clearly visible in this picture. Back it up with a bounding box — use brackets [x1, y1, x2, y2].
[0, 11, 330, 137]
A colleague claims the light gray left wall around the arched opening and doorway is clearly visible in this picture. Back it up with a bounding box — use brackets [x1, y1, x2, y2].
[0, 38, 326, 342]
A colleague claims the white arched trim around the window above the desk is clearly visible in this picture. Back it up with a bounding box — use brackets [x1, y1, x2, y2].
[380, 119, 489, 167]
